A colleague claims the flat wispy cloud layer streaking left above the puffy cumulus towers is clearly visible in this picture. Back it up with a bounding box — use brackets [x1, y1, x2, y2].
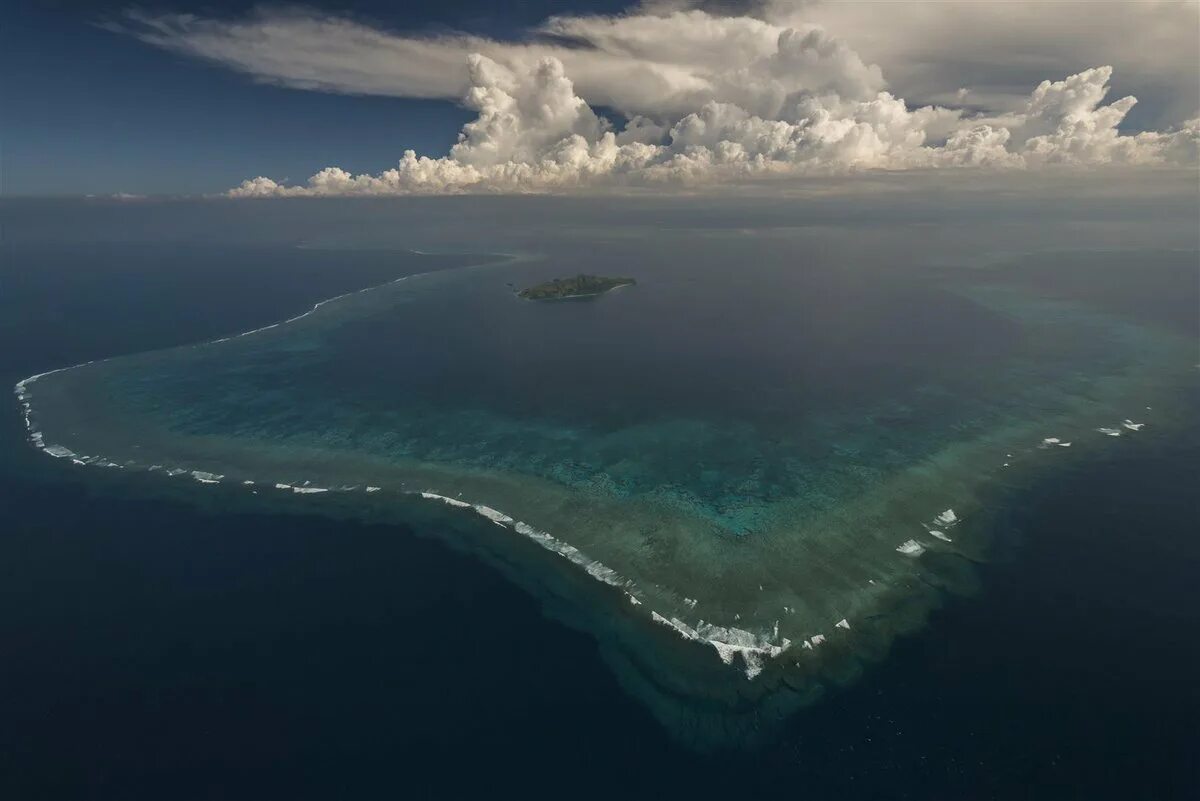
[124, 11, 883, 118]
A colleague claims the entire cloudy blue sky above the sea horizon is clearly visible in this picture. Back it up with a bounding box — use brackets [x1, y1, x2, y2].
[0, 0, 1200, 197]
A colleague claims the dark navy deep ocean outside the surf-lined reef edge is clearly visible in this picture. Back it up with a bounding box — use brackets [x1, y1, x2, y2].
[0, 209, 1200, 799]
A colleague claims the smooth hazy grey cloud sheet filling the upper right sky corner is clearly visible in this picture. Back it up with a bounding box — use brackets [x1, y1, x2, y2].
[777, 0, 1200, 125]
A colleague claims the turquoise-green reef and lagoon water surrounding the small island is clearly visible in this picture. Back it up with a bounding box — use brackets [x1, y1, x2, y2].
[19, 236, 1190, 733]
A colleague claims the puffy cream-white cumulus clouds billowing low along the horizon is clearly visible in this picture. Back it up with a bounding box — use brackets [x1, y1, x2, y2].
[230, 54, 1200, 197]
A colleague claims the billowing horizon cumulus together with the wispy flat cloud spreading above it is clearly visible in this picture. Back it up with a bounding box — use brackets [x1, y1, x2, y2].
[114, 4, 1200, 197]
